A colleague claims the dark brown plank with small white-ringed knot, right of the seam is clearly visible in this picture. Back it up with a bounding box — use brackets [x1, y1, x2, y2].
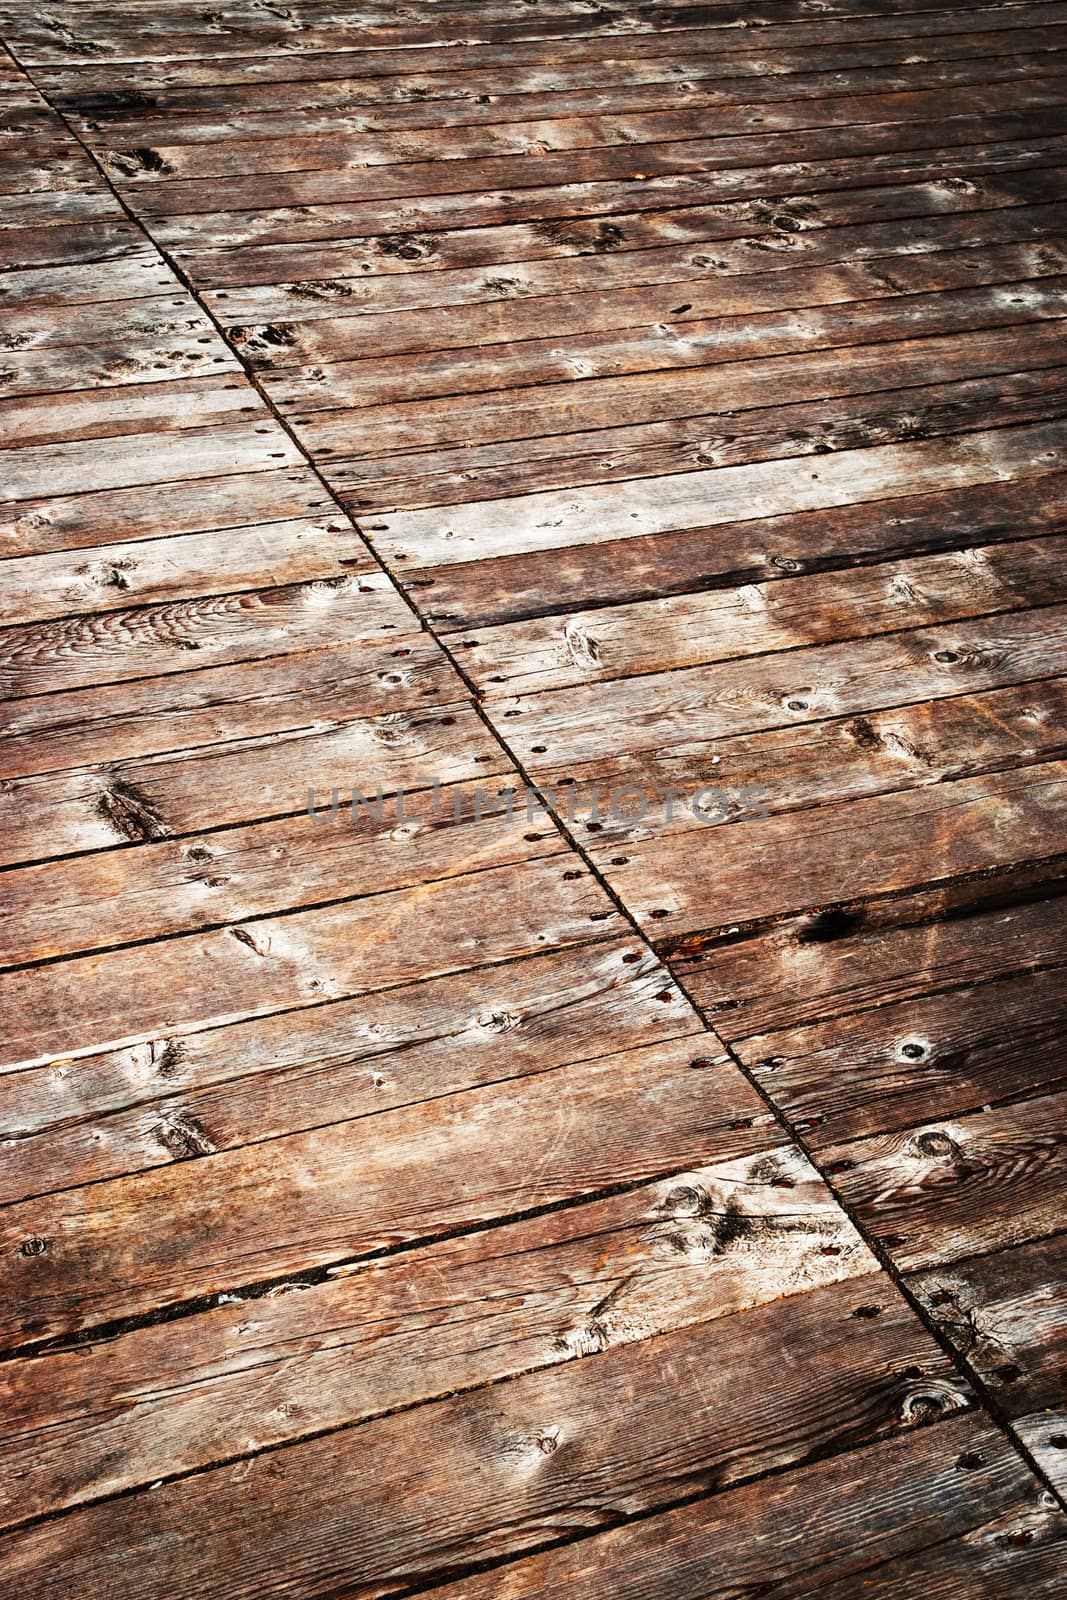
[734, 968, 1067, 1149]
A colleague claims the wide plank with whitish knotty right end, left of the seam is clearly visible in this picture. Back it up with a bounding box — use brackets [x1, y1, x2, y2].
[0, 1145, 875, 1523]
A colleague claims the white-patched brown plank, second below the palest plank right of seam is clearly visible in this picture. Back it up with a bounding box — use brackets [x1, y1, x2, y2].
[454, 536, 1067, 699]
